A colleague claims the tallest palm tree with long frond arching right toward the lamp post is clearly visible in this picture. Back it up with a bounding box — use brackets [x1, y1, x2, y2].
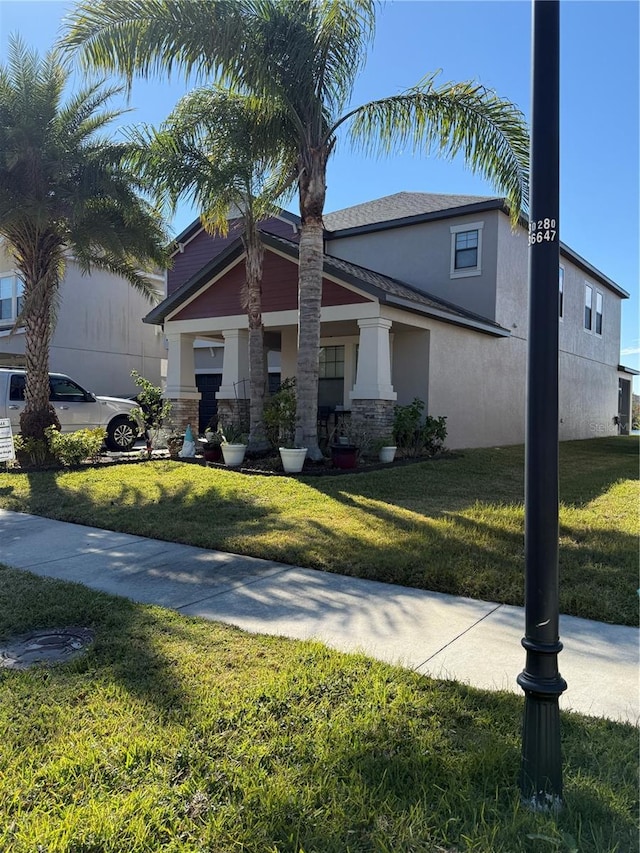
[65, 0, 529, 459]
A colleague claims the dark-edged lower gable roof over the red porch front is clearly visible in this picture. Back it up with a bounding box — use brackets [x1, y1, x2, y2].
[143, 232, 510, 337]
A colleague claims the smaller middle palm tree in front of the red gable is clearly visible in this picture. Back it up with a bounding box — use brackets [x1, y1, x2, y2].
[131, 87, 295, 451]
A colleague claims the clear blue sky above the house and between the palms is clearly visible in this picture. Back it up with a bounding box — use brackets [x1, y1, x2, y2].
[0, 0, 640, 386]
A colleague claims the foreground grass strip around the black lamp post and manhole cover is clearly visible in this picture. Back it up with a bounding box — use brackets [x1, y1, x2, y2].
[0, 564, 638, 853]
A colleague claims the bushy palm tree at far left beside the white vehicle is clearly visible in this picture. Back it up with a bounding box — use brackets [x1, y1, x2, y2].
[0, 38, 167, 439]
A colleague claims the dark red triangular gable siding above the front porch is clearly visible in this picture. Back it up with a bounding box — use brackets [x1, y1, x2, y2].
[171, 251, 370, 320]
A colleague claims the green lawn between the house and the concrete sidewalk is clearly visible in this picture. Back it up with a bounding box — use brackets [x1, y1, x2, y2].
[0, 437, 638, 625]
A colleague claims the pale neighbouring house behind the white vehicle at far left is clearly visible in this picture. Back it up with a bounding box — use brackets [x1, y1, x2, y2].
[0, 244, 167, 397]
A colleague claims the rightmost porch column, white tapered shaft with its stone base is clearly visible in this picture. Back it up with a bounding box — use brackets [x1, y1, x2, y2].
[349, 317, 398, 439]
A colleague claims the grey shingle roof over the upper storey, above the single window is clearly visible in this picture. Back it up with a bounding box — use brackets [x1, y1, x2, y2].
[324, 192, 501, 231]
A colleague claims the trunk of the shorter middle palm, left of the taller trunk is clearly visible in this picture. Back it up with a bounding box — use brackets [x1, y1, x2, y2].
[243, 224, 269, 453]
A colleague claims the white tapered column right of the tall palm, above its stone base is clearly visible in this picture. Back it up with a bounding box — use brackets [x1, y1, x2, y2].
[349, 317, 398, 400]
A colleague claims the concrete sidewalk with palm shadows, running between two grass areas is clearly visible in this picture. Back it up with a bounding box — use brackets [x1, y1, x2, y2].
[0, 510, 640, 724]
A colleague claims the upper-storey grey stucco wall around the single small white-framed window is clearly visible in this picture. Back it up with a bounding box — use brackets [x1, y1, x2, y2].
[327, 211, 505, 319]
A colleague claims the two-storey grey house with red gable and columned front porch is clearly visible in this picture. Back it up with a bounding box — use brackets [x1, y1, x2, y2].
[145, 193, 633, 448]
